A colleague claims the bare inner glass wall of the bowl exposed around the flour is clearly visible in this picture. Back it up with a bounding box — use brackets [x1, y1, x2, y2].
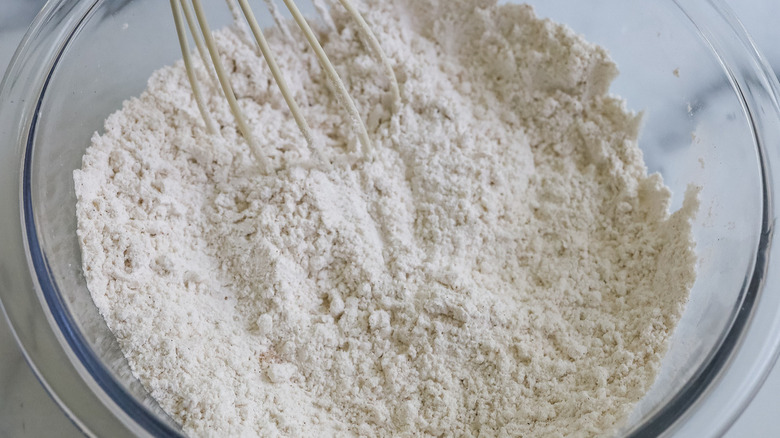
[24, 0, 764, 433]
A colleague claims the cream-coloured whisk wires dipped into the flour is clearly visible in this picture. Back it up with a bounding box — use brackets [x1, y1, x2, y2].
[170, 0, 400, 172]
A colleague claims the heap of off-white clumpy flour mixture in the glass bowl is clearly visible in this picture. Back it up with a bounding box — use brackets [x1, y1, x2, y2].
[74, 0, 697, 437]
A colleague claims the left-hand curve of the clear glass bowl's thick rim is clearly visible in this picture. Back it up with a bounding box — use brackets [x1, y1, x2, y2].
[0, 0, 183, 437]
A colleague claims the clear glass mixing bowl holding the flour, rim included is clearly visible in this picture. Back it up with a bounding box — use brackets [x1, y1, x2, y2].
[0, 0, 780, 437]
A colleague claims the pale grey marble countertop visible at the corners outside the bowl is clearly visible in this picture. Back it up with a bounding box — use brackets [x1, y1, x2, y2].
[0, 0, 780, 438]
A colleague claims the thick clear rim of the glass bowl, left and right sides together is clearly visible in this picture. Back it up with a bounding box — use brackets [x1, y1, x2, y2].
[0, 0, 780, 437]
